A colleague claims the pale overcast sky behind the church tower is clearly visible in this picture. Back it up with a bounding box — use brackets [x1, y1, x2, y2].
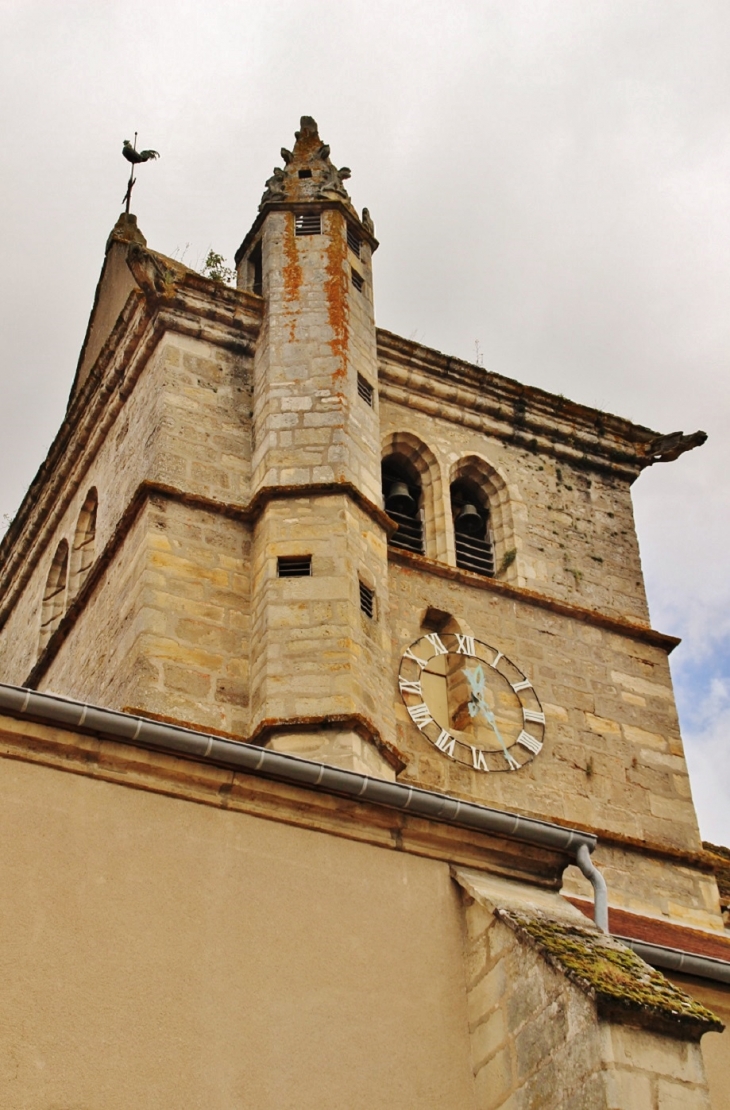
[0, 0, 730, 844]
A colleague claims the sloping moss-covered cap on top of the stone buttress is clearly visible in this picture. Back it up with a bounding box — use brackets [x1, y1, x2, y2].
[497, 909, 724, 1040]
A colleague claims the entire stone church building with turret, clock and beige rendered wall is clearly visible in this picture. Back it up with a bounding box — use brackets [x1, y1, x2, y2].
[0, 117, 730, 1110]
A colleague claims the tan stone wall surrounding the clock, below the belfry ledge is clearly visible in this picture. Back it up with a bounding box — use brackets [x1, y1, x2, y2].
[389, 563, 700, 851]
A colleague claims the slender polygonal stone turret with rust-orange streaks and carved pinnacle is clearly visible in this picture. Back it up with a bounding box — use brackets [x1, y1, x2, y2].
[236, 115, 398, 777]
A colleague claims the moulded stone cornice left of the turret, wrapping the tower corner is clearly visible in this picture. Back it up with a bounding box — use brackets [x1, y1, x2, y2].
[0, 253, 263, 612]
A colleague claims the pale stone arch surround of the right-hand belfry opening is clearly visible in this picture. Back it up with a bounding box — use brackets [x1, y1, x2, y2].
[447, 454, 524, 585]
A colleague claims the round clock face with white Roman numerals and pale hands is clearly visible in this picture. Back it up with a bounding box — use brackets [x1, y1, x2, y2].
[398, 633, 545, 771]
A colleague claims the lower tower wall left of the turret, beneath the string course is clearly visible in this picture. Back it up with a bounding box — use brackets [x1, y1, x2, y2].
[40, 497, 250, 736]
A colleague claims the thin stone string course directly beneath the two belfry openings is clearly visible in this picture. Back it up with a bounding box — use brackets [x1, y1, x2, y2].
[388, 547, 681, 655]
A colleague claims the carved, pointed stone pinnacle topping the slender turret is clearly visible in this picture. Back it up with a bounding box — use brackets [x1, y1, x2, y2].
[258, 115, 351, 209]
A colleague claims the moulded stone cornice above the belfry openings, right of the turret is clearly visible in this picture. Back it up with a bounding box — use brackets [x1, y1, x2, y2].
[377, 329, 692, 482]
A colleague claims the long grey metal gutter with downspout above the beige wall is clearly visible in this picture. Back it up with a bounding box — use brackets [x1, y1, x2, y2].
[0, 683, 608, 931]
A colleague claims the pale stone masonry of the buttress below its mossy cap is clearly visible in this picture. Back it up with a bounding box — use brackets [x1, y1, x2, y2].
[465, 879, 712, 1110]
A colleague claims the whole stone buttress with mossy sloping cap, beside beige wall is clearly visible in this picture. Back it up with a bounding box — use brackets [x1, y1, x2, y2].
[453, 867, 722, 1110]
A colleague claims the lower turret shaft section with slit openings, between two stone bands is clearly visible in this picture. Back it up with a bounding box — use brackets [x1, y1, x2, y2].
[251, 494, 394, 763]
